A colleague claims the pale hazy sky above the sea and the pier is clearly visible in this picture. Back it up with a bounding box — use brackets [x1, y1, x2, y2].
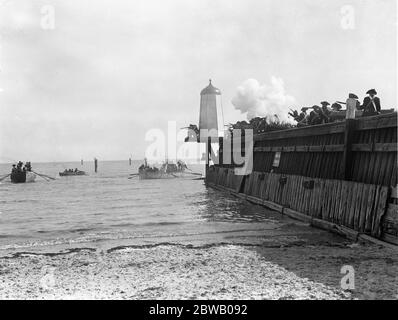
[0, 0, 397, 162]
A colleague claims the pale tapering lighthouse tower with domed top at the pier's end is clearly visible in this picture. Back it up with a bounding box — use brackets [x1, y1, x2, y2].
[199, 80, 224, 143]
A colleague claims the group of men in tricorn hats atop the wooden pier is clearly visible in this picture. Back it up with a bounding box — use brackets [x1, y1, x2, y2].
[289, 89, 381, 127]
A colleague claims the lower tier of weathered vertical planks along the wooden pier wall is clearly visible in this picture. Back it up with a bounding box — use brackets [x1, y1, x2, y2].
[208, 168, 398, 242]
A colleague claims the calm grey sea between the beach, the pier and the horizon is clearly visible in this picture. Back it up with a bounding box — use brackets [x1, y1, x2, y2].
[0, 161, 292, 254]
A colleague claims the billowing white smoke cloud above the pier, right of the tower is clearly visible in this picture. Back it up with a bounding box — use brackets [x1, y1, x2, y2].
[231, 77, 295, 121]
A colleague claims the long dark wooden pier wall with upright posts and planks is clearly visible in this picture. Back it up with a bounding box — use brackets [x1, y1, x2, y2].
[206, 113, 398, 245]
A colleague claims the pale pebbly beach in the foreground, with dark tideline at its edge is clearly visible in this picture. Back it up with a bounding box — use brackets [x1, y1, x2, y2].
[0, 243, 398, 299]
